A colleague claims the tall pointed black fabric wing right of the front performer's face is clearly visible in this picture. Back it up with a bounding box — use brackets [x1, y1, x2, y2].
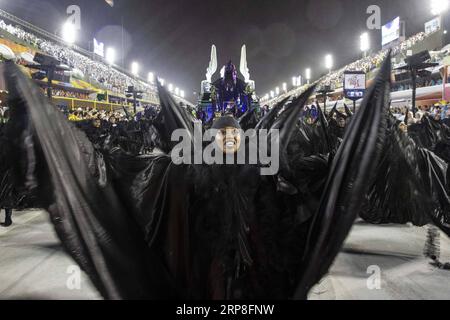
[295, 55, 391, 298]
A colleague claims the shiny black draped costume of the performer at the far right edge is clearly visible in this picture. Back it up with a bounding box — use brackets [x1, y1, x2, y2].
[361, 119, 450, 235]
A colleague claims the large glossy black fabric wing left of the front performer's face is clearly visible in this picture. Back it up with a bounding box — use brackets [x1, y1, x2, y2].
[5, 63, 177, 299]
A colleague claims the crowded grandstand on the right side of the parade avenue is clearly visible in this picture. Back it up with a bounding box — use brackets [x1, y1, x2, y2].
[261, 20, 450, 117]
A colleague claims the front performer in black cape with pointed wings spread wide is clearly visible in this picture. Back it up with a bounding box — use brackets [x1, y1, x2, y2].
[5, 52, 450, 299]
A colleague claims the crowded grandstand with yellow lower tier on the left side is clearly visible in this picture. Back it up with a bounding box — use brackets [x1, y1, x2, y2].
[0, 10, 191, 116]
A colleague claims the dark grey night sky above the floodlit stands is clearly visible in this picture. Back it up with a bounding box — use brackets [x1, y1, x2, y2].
[0, 0, 432, 100]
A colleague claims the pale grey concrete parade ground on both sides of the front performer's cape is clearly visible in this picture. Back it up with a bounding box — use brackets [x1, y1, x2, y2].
[0, 210, 450, 300]
